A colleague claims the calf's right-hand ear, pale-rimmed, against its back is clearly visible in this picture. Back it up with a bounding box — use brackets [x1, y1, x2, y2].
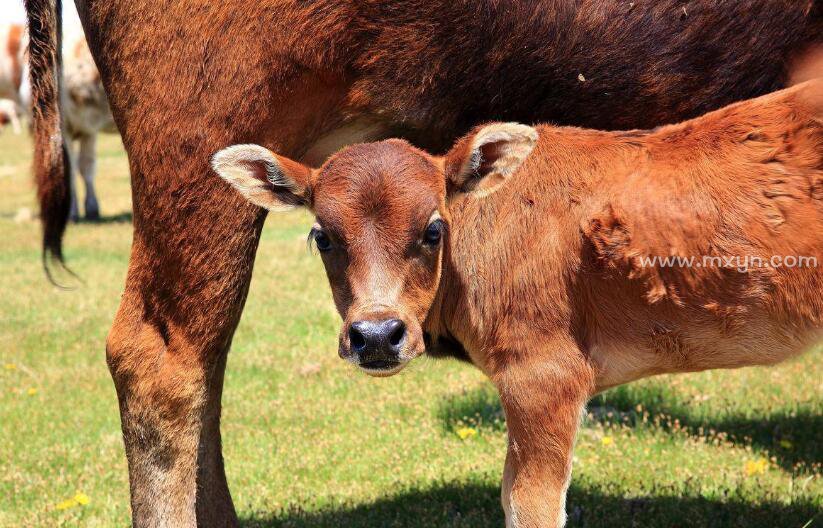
[444, 123, 537, 196]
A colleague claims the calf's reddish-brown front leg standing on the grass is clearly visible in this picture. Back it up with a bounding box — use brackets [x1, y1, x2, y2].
[495, 342, 592, 528]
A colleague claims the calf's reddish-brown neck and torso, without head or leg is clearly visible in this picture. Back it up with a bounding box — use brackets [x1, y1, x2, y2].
[441, 81, 823, 388]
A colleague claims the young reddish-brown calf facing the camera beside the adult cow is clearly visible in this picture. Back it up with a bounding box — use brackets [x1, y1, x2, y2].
[213, 81, 823, 527]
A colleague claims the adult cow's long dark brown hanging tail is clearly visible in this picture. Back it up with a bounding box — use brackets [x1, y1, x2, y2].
[25, 0, 71, 282]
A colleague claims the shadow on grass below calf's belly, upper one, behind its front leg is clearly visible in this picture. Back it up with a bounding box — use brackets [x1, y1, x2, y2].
[437, 385, 823, 471]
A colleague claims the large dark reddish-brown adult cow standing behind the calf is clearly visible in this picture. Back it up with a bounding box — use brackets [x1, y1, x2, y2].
[27, 0, 823, 526]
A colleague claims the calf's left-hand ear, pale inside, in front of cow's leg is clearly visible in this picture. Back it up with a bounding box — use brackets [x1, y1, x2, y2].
[211, 145, 314, 211]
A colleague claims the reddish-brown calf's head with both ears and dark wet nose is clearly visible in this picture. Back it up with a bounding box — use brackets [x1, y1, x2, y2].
[212, 123, 537, 376]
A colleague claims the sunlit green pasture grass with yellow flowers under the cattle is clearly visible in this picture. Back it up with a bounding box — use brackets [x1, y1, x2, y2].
[0, 129, 823, 528]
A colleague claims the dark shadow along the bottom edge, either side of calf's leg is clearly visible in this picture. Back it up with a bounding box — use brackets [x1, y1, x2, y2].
[241, 483, 819, 528]
